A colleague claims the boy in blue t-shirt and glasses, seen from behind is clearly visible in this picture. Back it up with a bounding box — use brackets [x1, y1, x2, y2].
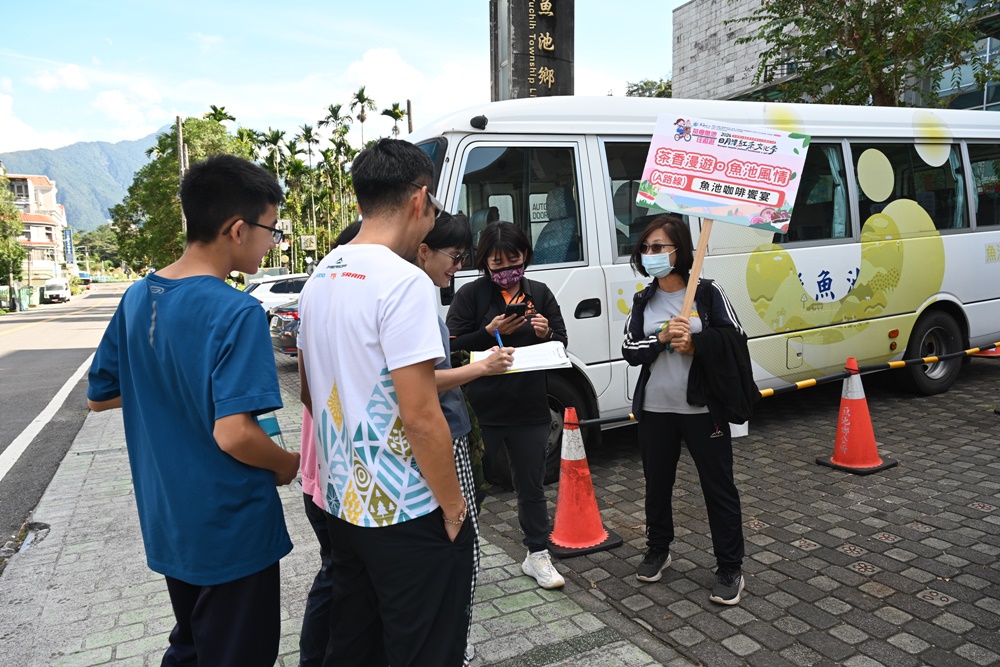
[87, 155, 299, 667]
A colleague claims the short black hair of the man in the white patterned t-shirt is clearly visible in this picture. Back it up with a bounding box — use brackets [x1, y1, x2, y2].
[351, 139, 434, 218]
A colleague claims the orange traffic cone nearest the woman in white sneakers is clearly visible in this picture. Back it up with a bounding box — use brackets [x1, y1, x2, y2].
[548, 408, 622, 558]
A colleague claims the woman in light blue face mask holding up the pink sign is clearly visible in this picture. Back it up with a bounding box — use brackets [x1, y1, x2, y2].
[622, 215, 753, 605]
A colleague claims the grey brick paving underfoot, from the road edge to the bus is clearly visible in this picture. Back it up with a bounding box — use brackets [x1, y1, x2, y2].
[0, 352, 1000, 667]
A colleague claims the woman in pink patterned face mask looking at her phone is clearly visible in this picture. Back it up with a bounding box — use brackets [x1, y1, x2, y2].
[447, 222, 567, 588]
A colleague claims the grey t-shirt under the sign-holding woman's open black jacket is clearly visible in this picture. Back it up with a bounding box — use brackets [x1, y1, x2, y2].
[642, 289, 708, 415]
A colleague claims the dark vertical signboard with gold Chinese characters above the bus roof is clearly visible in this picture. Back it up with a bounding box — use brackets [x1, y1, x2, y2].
[490, 0, 574, 101]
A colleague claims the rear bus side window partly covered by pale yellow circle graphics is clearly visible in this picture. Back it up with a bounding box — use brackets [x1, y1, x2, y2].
[851, 143, 969, 230]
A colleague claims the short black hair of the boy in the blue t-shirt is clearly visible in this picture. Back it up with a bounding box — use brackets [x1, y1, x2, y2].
[181, 155, 285, 243]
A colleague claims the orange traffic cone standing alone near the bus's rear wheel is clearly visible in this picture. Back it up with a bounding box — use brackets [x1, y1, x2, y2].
[816, 357, 899, 475]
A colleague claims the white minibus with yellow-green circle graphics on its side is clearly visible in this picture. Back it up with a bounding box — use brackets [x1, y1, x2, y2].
[408, 97, 1000, 462]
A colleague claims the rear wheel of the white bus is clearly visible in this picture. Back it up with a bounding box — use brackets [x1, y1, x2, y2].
[901, 310, 962, 396]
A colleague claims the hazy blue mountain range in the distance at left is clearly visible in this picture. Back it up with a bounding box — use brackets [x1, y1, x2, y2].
[0, 127, 162, 231]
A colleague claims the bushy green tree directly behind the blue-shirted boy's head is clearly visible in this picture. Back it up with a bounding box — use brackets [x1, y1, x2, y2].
[110, 118, 251, 270]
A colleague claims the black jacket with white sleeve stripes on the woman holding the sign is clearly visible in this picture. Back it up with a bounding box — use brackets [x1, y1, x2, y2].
[622, 280, 760, 424]
